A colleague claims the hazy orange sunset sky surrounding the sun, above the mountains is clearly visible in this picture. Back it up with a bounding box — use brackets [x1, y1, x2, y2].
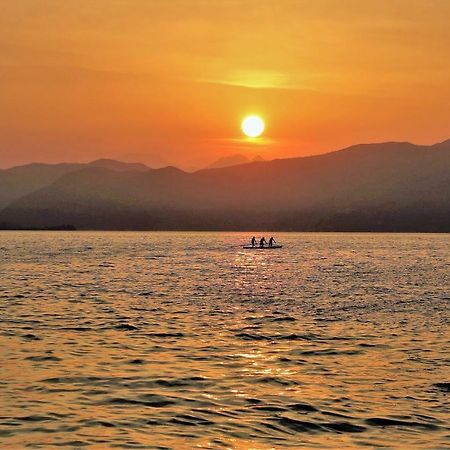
[0, 0, 450, 169]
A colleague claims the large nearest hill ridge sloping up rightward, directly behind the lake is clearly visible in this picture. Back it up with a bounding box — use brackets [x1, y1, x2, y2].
[0, 141, 450, 232]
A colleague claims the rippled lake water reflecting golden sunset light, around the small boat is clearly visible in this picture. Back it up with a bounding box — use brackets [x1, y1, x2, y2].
[0, 232, 450, 449]
